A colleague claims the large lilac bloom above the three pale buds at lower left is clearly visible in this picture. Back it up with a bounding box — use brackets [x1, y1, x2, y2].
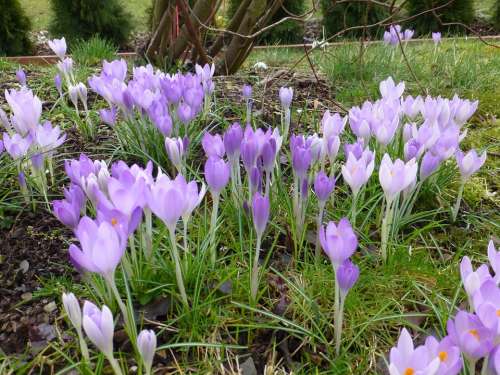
[69, 216, 127, 277]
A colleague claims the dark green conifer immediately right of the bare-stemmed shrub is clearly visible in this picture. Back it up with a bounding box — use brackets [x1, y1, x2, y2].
[321, 0, 389, 37]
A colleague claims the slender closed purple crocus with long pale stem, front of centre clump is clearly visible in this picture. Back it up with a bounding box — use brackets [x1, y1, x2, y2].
[250, 193, 270, 303]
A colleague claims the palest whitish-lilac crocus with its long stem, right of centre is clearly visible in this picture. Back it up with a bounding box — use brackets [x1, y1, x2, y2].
[379, 154, 418, 261]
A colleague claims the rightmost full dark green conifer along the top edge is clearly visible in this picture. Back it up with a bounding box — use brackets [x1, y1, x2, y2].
[407, 0, 474, 33]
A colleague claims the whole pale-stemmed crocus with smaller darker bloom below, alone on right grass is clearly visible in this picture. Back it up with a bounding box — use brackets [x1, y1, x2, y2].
[319, 218, 359, 355]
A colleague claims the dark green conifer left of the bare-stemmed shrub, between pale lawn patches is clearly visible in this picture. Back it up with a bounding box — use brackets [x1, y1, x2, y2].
[50, 0, 132, 46]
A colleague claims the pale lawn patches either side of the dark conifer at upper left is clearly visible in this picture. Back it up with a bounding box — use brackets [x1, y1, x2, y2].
[20, 0, 150, 31]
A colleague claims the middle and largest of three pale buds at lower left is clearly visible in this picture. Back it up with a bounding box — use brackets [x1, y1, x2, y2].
[83, 301, 115, 357]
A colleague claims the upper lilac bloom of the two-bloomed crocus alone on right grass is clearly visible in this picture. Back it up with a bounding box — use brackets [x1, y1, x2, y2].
[319, 218, 358, 268]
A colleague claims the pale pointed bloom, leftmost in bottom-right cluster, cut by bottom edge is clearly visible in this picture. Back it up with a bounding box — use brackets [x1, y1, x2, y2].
[389, 328, 440, 375]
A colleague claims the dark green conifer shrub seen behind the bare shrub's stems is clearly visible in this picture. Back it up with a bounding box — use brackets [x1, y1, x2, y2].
[227, 0, 306, 44]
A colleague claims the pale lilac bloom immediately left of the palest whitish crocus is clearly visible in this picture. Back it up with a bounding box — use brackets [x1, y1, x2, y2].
[342, 148, 375, 195]
